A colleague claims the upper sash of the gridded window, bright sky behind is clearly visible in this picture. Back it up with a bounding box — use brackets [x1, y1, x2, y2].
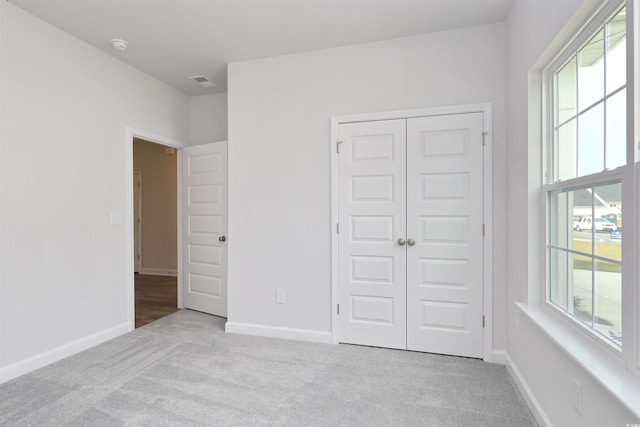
[552, 8, 627, 181]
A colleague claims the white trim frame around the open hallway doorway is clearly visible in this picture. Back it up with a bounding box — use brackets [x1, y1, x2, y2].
[124, 126, 185, 331]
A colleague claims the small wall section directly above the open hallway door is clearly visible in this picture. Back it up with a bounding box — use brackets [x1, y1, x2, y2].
[189, 93, 227, 145]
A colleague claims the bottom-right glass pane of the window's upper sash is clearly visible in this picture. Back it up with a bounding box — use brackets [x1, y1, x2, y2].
[607, 89, 627, 169]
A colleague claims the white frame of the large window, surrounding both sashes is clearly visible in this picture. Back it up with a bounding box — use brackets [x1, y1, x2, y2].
[540, 0, 640, 368]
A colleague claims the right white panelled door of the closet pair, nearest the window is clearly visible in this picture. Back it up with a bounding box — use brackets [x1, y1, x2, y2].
[407, 113, 483, 357]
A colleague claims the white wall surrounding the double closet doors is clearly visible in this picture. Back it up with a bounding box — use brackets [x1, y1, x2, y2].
[228, 24, 506, 349]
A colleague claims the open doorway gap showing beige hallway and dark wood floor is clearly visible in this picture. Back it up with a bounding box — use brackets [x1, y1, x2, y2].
[133, 137, 178, 328]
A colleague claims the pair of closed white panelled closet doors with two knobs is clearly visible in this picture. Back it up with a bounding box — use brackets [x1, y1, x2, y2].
[337, 112, 484, 358]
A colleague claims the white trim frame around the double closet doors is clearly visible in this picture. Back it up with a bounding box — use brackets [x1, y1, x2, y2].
[330, 103, 499, 362]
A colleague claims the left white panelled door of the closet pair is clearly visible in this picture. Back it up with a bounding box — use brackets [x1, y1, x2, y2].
[338, 120, 406, 349]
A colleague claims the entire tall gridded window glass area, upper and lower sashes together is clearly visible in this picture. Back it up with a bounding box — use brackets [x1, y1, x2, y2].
[544, 7, 634, 350]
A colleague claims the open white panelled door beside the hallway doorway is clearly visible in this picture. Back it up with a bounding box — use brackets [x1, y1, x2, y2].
[182, 141, 227, 317]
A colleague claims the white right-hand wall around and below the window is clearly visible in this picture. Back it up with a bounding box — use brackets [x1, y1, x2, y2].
[506, 0, 637, 426]
